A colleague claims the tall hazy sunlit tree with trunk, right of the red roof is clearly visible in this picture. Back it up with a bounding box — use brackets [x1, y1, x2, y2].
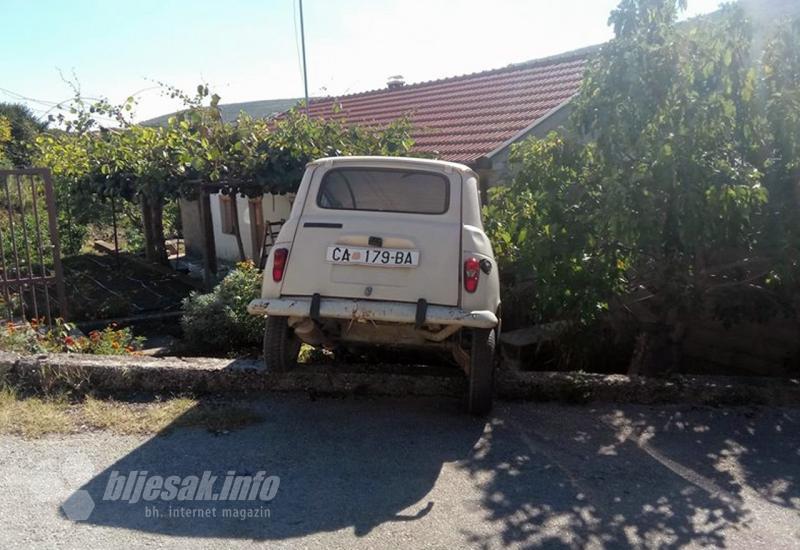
[576, 0, 780, 372]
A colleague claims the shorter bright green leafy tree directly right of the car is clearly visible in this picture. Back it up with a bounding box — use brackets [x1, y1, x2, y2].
[484, 132, 624, 325]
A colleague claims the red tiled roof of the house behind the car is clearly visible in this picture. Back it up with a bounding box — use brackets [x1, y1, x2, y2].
[309, 48, 594, 163]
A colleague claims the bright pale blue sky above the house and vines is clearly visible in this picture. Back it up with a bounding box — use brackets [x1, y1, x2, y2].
[0, 0, 720, 123]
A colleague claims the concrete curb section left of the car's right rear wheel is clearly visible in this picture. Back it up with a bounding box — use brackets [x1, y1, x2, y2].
[0, 352, 466, 395]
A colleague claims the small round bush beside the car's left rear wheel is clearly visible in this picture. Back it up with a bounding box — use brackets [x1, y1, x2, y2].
[181, 261, 264, 353]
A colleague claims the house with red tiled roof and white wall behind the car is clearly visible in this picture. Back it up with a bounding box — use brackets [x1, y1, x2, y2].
[181, 47, 597, 267]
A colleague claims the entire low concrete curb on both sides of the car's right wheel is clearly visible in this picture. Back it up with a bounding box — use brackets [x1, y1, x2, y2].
[0, 352, 800, 405]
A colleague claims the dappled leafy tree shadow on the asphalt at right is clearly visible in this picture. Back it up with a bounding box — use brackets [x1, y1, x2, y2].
[462, 407, 800, 548]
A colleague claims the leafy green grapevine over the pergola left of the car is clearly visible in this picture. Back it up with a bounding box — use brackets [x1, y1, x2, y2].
[37, 85, 413, 262]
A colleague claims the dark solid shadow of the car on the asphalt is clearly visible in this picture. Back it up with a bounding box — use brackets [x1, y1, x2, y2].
[67, 397, 485, 540]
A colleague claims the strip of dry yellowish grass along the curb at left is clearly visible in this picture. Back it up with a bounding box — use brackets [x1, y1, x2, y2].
[0, 388, 263, 438]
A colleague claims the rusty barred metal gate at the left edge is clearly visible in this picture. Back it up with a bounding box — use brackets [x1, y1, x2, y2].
[0, 168, 67, 325]
